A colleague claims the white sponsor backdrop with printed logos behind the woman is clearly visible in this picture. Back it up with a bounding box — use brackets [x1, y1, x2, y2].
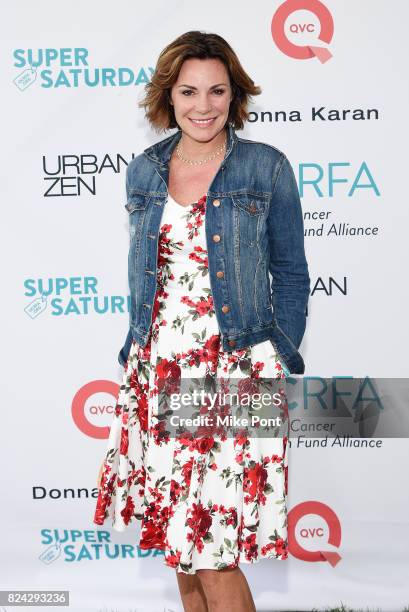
[0, 0, 409, 612]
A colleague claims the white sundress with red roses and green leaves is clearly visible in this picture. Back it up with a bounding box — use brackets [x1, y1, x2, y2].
[93, 195, 289, 574]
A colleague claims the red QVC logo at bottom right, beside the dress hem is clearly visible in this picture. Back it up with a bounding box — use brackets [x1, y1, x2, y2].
[287, 501, 341, 567]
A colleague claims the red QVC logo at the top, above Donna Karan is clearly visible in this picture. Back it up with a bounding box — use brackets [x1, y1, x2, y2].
[271, 0, 334, 64]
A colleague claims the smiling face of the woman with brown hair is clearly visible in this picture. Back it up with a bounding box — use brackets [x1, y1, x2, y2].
[171, 58, 232, 142]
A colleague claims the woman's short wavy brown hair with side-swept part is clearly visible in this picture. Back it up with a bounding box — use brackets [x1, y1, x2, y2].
[138, 30, 261, 131]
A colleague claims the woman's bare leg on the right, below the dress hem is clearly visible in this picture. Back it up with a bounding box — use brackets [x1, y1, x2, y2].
[197, 567, 256, 612]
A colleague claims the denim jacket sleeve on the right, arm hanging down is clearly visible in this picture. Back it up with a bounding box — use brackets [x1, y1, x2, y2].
[267, 153, 310, 350]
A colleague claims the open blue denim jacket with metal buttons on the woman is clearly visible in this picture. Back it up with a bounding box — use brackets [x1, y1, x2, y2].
[118, 124, 310, 374]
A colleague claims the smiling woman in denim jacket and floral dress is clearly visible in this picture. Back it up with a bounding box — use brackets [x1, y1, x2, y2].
[94, 31, 309, 612]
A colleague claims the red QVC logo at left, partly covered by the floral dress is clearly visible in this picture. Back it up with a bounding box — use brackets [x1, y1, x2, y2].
[71, 380, 119, 440]
